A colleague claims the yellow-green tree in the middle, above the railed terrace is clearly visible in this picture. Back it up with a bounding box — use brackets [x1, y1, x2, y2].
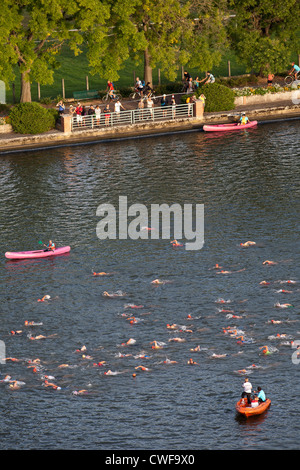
[88, 0, 226, 84]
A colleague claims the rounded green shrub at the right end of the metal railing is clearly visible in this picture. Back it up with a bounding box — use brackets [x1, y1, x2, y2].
[196, 83, 234, 112]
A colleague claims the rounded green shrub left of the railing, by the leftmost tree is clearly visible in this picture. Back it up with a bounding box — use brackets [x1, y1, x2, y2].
[9, 102, 55, 134]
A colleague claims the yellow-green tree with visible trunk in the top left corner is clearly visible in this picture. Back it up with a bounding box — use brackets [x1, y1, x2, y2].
[0, 0, 109, 102]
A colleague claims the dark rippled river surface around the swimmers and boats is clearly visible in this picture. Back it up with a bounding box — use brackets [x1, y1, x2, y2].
[0, 121, 300, 451]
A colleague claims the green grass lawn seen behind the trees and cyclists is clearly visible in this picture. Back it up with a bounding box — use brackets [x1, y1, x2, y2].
[6, 48, 245, 103]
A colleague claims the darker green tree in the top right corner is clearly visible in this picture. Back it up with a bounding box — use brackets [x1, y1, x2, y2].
[228, 0, 300, 75]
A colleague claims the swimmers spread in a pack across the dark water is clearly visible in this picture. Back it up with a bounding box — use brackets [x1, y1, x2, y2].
[0, 240, 296, 396]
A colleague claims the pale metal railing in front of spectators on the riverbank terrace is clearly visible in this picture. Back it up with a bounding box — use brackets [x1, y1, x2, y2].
[72, 103, 194, 131]
